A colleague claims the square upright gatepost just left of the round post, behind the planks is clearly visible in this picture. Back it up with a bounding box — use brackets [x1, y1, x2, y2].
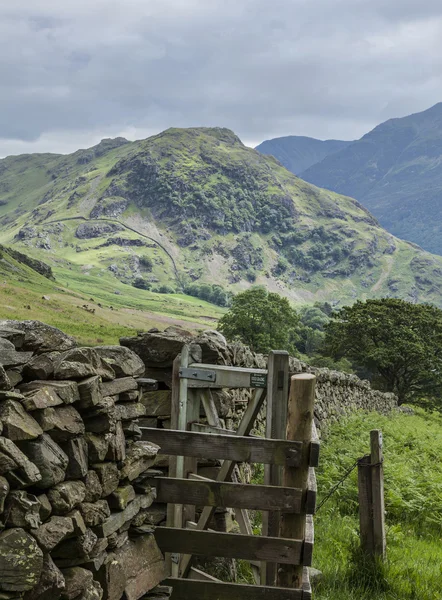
[261, 351, 289, 585]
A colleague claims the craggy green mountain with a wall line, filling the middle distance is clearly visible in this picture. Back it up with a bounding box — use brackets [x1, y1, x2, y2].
[0, 128, 442, 310]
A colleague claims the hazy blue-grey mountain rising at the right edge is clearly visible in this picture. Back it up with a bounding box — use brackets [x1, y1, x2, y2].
[301, 103, 442, 254]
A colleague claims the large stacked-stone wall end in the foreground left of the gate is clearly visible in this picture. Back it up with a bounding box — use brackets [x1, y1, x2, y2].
[0, 321, 167, 600]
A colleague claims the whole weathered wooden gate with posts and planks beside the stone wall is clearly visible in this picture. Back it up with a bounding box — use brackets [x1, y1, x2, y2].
[142, 347, 319, 600]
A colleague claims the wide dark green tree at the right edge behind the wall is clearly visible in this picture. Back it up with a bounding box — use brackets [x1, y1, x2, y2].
[324, 298, 442, 405]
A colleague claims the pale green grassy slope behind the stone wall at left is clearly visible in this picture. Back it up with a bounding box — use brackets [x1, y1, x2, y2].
[0, 247, 223, 345]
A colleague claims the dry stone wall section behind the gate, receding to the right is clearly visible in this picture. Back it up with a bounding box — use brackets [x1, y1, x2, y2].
[120, 327, 397, 436]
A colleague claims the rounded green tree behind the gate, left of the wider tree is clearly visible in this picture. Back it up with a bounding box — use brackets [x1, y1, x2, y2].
[218, 287, 299, 353]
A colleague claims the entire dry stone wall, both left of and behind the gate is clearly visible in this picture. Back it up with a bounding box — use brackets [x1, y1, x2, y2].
[0, 321, 396, 600]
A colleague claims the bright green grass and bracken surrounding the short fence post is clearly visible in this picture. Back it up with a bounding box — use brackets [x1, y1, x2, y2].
[314, 410, 442, 600]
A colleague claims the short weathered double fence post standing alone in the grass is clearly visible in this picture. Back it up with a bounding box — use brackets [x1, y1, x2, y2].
[358, 429, 386, 559]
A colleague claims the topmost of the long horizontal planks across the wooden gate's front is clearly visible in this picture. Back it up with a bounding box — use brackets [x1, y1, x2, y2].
[141, 427, 302, 467]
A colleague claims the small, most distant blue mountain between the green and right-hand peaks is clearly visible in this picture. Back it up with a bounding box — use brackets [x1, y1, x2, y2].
[255, 135, 351, 175]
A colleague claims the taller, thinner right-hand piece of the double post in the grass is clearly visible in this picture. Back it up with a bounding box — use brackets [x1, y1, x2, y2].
[370, 429, 386, 559]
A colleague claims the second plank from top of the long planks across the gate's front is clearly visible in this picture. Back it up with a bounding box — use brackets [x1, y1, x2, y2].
[149, 477, 302, 513]
